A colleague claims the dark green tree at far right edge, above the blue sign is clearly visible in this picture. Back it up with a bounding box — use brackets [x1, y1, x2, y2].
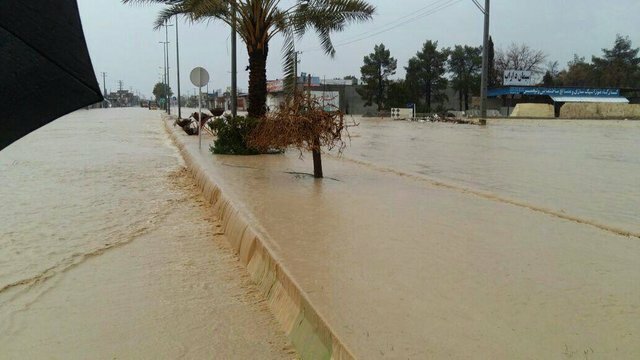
[591, 34, 640, 87]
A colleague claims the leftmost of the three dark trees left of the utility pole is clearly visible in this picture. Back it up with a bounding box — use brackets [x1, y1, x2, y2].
[358, 44, 398, 110]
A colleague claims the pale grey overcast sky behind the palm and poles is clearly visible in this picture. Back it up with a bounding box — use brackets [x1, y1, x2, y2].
[78, 0, 640, 97]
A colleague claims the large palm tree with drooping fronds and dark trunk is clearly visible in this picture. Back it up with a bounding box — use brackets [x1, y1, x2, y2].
[122, 0, 375, 118]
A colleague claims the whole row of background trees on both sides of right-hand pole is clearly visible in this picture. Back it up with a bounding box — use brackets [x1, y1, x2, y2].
[360, 35, 640, 112]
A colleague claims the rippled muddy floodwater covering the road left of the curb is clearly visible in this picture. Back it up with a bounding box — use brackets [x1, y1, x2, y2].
[0, 109, 293, 359]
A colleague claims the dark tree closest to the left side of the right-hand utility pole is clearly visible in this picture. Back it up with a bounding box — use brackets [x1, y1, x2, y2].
[447, 45, 482, 110]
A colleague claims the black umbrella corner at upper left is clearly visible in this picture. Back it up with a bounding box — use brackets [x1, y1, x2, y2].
[0, 0, 103, 150]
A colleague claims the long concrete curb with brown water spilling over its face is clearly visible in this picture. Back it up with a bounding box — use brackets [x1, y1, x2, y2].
[162, 116, 355, 360]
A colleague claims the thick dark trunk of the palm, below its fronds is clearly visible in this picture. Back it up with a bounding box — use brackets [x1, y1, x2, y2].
[247, 46, 269, 118]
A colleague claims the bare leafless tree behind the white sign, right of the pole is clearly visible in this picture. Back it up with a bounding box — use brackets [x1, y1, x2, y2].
[495, 43, 547, 81]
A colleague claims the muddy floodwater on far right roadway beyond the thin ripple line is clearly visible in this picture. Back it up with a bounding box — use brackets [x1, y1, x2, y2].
[345, 118, 640, 235]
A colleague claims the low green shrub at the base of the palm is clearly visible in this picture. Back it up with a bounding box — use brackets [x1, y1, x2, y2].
[208, 116, 259, 155]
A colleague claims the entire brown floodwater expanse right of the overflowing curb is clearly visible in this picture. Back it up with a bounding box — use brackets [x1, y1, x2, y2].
[169, 119, 640, 359]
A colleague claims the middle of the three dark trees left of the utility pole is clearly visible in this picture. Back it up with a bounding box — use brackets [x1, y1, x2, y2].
[405, 40, 450, 112]
